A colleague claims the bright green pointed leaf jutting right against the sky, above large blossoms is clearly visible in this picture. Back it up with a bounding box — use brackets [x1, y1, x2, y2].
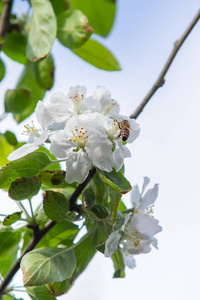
[73, 39, 121, 71]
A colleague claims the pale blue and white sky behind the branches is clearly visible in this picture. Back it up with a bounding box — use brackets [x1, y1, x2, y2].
[0, 0, 200, 300]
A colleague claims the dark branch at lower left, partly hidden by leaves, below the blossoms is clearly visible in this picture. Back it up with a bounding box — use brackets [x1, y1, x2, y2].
[0, 168, 96, 299]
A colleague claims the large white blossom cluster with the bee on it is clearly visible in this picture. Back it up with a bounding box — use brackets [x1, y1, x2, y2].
[8, 86, 140, 183]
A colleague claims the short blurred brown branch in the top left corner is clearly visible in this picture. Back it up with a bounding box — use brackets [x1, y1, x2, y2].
[0, 0, 13, 50]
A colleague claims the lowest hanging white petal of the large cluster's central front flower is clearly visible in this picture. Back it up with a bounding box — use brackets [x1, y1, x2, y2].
[65, 150, 91, 183]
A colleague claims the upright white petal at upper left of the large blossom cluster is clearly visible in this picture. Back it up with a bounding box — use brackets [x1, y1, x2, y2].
[35, 101, 53, 130]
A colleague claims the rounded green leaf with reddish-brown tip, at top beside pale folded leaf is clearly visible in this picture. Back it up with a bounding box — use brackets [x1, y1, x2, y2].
[57, 9, 94, 49]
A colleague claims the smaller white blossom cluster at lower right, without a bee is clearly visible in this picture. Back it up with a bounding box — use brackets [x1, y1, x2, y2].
[104, 177, 162, 269]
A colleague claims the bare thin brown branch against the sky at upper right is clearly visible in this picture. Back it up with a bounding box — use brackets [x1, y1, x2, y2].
[130, 10, 200, 119]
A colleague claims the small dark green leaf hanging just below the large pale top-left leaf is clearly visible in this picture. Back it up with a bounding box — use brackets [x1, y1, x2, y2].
[31, 55, 55, 90]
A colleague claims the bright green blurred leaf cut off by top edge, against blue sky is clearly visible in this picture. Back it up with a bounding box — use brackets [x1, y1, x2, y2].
[70, 0, 116, 37]
